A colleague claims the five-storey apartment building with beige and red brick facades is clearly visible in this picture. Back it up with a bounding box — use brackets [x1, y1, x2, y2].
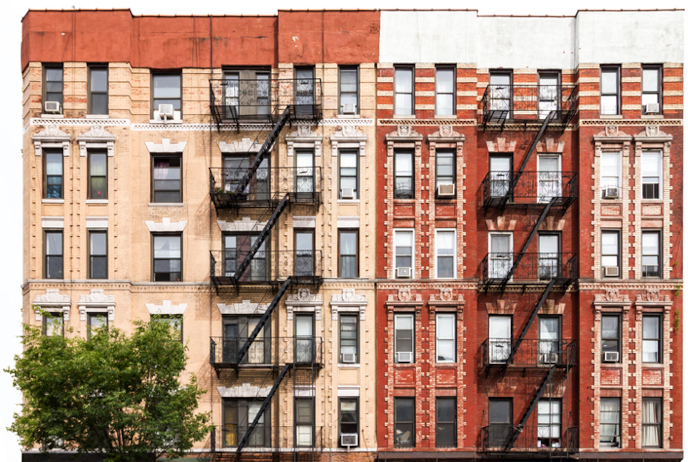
[22, 6, 683, 462]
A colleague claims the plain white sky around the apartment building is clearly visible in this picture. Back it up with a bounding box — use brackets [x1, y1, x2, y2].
[0, 0, 688, 462]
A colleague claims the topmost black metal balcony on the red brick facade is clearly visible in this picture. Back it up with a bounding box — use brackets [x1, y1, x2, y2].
[480, 84, 578, 130]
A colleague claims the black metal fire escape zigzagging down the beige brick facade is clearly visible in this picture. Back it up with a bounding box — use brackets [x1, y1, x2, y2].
[210, 78, 323, 461]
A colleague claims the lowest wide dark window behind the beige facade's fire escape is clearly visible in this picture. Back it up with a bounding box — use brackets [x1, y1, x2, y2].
[222, 398, 271, 447]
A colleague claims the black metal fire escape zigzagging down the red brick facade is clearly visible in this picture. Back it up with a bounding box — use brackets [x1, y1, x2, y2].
[480, 85, 578, 457]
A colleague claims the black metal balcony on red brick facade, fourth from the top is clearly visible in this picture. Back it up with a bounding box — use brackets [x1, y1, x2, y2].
[481, 338, 576, 368]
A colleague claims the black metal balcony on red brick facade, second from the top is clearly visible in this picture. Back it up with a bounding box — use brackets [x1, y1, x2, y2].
[481, 172, 578, 209]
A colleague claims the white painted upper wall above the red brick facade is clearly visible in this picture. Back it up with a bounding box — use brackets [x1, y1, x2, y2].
[380, 11, 683, 69]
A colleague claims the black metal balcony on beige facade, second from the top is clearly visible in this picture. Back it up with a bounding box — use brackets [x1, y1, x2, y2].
[210, 167, 323, 210]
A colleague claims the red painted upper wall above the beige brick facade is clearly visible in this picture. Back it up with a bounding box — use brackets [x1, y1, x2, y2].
[21, 10, 380, 69]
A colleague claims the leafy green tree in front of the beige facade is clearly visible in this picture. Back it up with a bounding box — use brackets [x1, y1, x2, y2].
[6, 321, 211, 461]
